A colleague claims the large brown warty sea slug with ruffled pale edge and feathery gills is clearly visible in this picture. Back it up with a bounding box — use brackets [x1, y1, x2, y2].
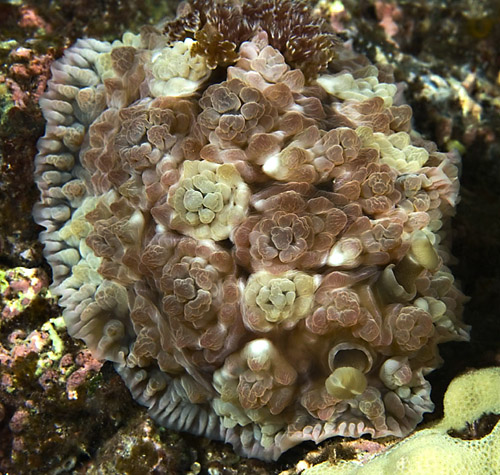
[34, 0, 468, 459]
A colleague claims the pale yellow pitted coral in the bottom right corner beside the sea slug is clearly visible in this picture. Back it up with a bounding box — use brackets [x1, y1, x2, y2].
[303, 368, 500, 475]
